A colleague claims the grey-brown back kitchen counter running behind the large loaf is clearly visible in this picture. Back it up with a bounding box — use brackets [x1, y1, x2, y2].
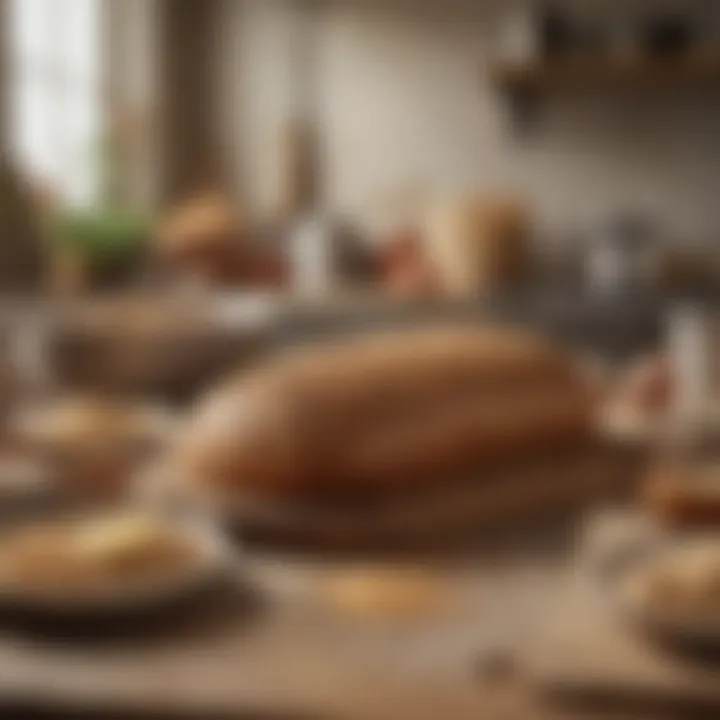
[0, 289, 671, 394]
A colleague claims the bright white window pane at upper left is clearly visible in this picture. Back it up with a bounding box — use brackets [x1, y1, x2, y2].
[9, 0, 103, 205]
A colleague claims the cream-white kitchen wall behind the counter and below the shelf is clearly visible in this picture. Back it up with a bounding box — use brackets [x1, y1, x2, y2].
[217, 0, 720, 240]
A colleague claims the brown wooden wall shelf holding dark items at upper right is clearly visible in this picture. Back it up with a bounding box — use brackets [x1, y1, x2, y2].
[491, 54, 720, 94]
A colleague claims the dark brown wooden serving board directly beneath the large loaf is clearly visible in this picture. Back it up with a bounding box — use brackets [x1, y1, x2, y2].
[225, 442, 642, 549]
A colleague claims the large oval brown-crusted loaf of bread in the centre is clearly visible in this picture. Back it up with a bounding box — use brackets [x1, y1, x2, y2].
[174, 328, 593, 499]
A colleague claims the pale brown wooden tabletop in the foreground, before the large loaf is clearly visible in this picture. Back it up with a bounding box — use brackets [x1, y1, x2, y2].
[0, 524, 572, 720]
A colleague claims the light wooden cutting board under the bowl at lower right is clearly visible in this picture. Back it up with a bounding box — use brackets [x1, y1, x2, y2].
[523, 512, 720, 717]
